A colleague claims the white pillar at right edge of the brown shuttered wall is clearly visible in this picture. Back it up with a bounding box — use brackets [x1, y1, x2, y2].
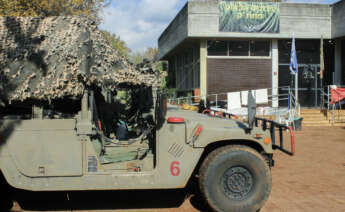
[272, 39, 279, 107]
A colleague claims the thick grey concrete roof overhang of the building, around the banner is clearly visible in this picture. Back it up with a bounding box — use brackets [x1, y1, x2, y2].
[158, 0, 345, 60]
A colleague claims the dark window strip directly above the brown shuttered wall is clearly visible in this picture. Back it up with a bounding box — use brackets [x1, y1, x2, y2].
[207, 40, 271, 57]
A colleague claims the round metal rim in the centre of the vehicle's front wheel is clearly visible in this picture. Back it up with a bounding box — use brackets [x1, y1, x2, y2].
[221, 166, 254, 200]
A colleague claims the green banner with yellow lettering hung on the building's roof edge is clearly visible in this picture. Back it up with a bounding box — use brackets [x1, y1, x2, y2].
[219, 1, 280, 33]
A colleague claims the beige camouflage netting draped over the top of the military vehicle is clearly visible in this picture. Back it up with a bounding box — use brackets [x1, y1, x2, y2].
[0, 17, 160, 102]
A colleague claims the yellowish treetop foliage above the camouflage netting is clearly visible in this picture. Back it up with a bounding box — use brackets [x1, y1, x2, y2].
[0, 0, 111, 21]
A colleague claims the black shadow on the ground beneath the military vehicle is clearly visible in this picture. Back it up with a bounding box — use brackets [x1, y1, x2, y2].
[0, 173, 215, 212]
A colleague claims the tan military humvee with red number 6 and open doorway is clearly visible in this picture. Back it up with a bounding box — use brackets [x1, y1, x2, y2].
[0, 89, 294, 211]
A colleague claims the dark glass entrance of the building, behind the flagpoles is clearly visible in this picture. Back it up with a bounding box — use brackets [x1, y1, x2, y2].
[279, 40, 334, 108]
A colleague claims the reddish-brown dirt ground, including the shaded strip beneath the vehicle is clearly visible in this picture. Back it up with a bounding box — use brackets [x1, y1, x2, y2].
[12, 127, 345, 212]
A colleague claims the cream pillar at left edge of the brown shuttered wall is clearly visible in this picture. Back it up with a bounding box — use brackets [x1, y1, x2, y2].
[200, 40, 207, 99]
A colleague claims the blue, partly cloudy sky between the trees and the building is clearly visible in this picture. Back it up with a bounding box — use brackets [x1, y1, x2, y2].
[100, 0, 339, 52]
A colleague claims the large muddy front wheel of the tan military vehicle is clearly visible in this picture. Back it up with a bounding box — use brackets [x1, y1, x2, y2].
[199, 145, 272, 212]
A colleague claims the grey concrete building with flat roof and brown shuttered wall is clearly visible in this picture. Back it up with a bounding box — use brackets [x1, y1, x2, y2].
[158, 0, 345, 107]
